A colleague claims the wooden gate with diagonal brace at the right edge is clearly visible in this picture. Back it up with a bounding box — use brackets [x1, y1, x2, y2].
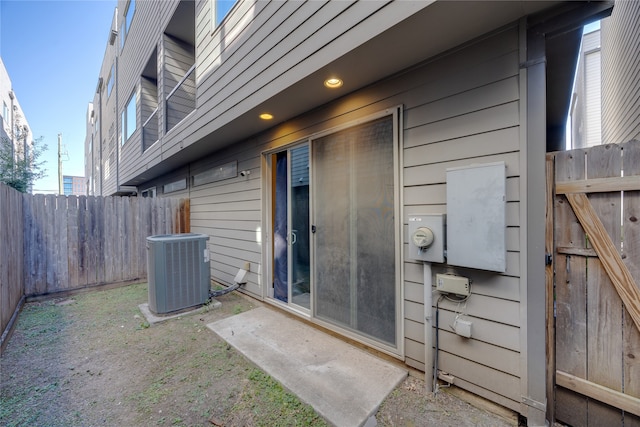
[547, 141, 640, 427]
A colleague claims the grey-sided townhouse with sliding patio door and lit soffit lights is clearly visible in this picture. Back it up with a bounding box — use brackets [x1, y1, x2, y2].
[86, 0, 611, 426]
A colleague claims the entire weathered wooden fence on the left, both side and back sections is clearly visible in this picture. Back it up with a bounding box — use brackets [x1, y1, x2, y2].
[0, 184, 190, 352]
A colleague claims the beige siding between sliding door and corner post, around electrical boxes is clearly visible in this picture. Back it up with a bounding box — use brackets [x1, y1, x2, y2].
[403, 23, 524, 410]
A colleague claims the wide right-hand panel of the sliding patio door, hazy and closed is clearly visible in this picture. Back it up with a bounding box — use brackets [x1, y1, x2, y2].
[312, 117, 396, 346]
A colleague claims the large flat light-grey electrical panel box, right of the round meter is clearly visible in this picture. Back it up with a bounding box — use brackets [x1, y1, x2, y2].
[447, 162, 507, 273]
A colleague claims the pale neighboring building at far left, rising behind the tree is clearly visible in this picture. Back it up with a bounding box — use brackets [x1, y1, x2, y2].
[0, 58, 33, 192]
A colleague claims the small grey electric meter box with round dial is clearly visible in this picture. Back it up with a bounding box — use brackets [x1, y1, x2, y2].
[408, 214, 445, 262]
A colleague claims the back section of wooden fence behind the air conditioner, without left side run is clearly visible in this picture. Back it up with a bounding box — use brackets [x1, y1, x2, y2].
[24, 194, 189, 296]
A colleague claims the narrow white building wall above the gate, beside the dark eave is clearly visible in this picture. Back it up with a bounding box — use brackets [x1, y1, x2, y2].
[571, 29, 602, 148]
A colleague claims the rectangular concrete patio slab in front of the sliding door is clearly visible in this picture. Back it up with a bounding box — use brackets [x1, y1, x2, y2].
[207, 307, 408, 427]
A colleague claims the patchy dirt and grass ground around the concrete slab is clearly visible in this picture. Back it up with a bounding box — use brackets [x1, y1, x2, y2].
[0, 284, 517, 427]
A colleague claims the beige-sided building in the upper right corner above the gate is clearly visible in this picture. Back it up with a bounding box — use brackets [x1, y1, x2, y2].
[601, 1, 640, 144]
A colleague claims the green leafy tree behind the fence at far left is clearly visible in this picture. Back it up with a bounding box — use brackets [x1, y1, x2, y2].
[0, 134, 47, 193]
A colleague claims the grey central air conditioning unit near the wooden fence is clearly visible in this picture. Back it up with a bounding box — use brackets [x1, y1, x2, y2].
[147, 233, 211, 314]
